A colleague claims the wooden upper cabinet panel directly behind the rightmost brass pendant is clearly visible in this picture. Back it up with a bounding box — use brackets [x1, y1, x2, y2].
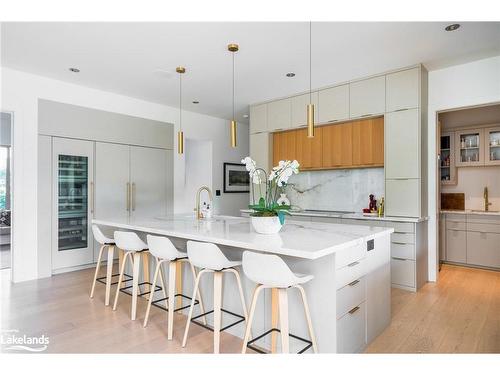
[294, 127, 324, 169]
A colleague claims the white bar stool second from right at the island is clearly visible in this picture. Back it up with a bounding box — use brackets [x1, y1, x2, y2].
[182, 241, 248, 353]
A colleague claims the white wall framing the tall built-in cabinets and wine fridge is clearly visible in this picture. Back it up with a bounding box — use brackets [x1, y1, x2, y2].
[0, 68, 248, 282]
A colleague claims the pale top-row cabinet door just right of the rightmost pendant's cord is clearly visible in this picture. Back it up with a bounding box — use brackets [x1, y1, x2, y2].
[317, 85, 349, 124]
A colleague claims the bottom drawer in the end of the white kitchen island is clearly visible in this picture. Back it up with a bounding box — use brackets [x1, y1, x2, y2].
[337, 302, 366, 353]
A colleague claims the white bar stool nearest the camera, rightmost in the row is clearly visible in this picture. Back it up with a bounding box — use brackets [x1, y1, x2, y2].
[241, 251, 318, 354]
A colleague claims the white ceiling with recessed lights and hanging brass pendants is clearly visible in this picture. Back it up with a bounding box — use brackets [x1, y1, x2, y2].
[2, 22, 500, 121]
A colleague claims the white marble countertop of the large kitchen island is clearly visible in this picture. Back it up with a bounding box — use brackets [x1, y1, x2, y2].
[92, 215, 394, 259]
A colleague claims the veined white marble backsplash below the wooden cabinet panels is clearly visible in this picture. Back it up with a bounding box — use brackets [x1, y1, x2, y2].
[286, 168, 384, 212]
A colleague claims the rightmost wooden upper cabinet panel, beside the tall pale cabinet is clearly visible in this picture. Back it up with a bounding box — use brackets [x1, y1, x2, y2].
[351, 117, 384, 166]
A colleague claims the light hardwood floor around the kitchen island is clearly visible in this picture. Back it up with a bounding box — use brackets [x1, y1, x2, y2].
[0, 266, 500, 353]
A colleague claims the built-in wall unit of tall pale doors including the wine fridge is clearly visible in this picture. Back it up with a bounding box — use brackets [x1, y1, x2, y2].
[37, 100, 174, 277]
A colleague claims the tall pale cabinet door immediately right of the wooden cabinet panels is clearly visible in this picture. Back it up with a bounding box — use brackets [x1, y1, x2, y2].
[384, 109, 420, 179]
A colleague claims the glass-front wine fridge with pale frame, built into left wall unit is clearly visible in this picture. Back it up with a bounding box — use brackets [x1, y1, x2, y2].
[52, 137, 94, 271]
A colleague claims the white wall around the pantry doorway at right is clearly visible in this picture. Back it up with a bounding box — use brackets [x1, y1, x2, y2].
[428, 56, 500, 281]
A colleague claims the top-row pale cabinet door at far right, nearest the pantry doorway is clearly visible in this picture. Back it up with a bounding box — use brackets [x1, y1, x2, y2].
[385, 68, 420, 112]
